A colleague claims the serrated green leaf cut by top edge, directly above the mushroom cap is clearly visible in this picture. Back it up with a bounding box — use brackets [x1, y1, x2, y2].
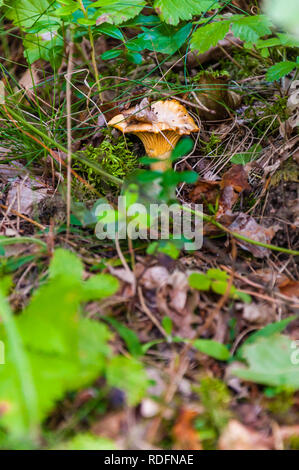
[154, 0, 218, 25]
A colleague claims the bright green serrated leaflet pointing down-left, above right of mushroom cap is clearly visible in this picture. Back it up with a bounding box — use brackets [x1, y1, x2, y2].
[191, 20, 230, 54]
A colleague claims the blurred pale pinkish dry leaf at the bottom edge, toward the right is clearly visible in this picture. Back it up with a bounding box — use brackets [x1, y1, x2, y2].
[218, 419, 273, 450]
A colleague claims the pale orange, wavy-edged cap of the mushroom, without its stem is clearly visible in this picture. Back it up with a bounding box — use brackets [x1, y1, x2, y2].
[108, 100, 199, 135]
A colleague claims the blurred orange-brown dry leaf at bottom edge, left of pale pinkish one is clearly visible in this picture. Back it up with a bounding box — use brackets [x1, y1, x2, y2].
[172, 408, 202, 450]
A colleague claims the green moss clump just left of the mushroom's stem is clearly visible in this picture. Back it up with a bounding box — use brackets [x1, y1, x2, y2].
[73, 129, 138, 194]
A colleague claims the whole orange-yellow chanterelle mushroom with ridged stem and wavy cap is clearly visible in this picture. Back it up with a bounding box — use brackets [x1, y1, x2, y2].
[108, 99, 199, 171]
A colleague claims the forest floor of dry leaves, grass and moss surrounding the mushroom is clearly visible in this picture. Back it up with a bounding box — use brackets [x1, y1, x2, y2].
[0, 3, 299, 450]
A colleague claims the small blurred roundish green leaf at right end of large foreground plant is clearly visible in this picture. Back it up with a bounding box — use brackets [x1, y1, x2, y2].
[106, 356, 149, 405]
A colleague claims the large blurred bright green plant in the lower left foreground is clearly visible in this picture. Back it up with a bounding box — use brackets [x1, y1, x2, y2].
[0, 249, 147, 446]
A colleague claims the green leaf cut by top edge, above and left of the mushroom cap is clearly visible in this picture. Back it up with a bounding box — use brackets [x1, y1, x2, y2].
[90, 0, 146, 24]
